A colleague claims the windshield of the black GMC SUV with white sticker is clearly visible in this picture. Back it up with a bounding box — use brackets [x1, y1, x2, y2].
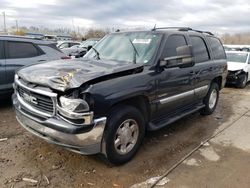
[85, 32, 161, 63]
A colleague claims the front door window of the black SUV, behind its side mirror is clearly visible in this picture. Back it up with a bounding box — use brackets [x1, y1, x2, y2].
[163, 35, 187, 58]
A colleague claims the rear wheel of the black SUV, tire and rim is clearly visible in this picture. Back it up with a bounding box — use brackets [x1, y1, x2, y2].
[200, 82, 219, 115]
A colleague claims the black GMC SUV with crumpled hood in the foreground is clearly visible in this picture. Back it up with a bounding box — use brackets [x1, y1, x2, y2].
[13, 28, 227, 164]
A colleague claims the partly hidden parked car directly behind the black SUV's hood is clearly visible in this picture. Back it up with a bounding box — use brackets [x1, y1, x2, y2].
[62, 38, 100, 58]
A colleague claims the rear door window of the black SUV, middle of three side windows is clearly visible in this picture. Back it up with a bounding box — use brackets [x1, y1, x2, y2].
[190, 36, 209, 63]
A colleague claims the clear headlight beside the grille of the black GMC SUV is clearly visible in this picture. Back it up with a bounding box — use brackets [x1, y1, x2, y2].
[60, 96, 89, 113]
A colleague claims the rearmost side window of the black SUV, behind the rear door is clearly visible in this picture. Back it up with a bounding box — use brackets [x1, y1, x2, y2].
[208, 37, 226, 59]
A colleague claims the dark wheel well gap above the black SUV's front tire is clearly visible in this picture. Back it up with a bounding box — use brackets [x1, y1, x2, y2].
[111, 96, 150, 122]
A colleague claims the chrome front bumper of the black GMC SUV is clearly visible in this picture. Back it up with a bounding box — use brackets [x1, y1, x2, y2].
[16, 110, 107, 154]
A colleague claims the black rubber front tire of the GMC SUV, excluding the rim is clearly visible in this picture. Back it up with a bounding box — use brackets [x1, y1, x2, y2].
[104, 105, 145, 164]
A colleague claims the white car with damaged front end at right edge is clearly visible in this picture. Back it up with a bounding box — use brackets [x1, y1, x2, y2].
[227, 51, 250, 88]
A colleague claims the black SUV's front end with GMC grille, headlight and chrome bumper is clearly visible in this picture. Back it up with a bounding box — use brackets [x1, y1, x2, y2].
[13, 75, 106, 154]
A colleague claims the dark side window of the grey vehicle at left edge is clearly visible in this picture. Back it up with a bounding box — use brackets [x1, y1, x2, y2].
[8, 41, 40, 59]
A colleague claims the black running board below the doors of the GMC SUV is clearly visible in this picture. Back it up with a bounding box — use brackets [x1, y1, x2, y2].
[148, 103, 205, 131]
